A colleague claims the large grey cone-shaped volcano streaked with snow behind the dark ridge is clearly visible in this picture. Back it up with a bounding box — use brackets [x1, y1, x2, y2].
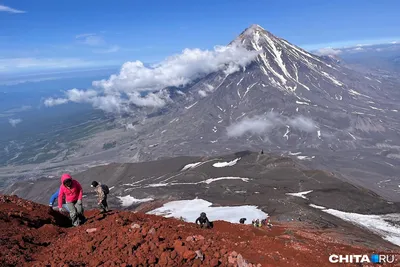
[115, 25, 400, 200]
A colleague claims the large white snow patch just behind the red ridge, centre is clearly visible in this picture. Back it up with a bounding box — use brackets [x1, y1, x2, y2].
[148, 198, 268, 224]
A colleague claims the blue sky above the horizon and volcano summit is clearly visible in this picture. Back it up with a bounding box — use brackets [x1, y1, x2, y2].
[0, 0, 400, 73]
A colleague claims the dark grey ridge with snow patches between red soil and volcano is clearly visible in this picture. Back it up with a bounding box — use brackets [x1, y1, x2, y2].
[5, 151, 400, 250]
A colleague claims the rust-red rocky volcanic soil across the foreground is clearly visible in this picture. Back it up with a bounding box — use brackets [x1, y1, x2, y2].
[0, 195, 400, 267]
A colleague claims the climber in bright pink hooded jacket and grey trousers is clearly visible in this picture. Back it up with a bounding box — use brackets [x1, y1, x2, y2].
[58, 174, 86, 226]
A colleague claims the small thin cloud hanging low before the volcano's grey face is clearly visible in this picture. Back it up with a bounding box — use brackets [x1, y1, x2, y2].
[226, 112, 316, 137]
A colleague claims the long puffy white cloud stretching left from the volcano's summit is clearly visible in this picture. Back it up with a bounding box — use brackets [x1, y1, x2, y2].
[45, 42, 258, 112]
